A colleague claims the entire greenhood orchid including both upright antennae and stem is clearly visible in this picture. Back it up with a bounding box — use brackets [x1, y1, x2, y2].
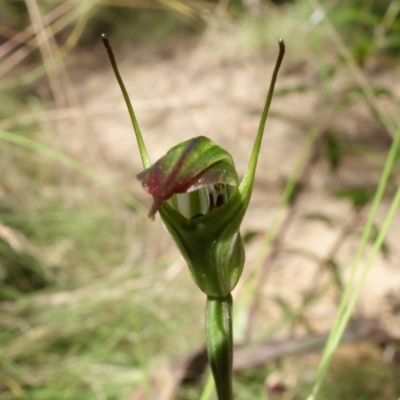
[102, 35, 285, 400]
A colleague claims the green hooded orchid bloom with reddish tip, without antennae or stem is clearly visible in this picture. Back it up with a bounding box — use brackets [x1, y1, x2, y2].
[138, 137, 245, 297]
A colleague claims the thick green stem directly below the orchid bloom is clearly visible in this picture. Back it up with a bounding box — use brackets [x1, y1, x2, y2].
[206, 294, 233, 400]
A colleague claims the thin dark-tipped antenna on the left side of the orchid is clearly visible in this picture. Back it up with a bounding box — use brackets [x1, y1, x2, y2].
[101, 33, 151, 169]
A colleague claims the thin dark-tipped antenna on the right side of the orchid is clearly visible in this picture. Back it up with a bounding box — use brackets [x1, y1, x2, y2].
[239, 38, 285, 198]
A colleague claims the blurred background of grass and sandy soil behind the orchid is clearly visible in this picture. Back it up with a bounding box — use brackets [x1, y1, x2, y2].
[0, 0, 400, 400]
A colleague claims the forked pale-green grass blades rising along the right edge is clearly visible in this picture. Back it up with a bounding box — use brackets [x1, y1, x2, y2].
[307, 123, 400, 400]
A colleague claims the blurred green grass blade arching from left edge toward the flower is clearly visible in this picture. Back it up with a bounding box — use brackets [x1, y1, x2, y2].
[0, 130, 147, 215]
